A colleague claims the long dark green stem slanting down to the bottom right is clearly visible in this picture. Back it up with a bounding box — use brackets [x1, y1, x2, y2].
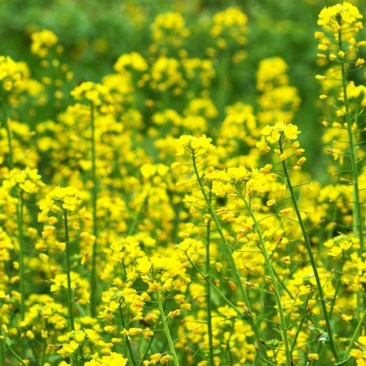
[279, 138, 339, 362]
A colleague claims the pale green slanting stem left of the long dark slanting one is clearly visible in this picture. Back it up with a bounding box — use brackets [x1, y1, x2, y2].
[243, 197, 291, 365]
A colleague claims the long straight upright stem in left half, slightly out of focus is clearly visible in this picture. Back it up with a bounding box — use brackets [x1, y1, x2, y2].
[90, 103, 98, 318]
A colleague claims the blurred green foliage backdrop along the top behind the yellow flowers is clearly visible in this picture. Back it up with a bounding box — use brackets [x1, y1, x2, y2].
[0, 0, 366, 177]
